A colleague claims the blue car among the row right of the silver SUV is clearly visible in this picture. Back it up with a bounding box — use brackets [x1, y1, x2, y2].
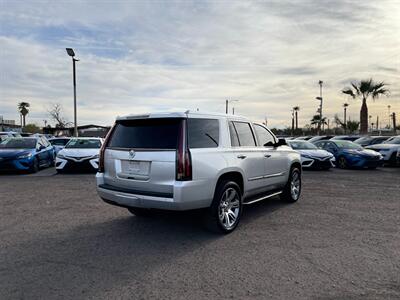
[314, 140, 383, 169]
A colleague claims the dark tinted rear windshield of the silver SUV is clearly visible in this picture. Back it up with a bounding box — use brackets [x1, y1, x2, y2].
[108, 118, 182, 150]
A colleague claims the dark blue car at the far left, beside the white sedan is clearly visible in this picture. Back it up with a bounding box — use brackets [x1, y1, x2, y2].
[0, 137, 55, 173]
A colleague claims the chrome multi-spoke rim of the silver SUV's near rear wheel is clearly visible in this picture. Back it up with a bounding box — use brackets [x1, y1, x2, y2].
[218, 188, 240, 230]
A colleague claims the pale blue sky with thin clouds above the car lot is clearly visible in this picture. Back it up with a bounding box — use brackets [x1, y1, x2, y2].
[0, 0, 400, 127]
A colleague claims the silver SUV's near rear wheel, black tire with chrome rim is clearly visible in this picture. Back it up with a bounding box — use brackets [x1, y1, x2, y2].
[204, 180, 243, 234]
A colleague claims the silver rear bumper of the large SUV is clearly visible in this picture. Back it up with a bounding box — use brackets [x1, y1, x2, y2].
[96, 173, 213, 210]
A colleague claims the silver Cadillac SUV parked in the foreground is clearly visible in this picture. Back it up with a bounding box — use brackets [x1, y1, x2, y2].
[96, 112, 301, 233]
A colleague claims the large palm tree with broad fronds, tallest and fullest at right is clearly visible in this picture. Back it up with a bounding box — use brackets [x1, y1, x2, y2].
[342, 78, 389, 133]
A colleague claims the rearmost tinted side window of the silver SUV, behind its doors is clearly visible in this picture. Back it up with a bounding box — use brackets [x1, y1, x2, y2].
[187, 119, 219, 148]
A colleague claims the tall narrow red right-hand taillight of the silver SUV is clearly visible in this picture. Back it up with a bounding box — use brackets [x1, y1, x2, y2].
[176, 119, 192, 181]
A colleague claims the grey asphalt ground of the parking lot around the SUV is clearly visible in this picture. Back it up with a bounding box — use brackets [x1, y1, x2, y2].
[0, 168, 400, 299]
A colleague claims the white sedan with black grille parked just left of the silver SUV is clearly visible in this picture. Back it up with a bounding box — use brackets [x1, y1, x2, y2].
[56, 138, 103, 173]
